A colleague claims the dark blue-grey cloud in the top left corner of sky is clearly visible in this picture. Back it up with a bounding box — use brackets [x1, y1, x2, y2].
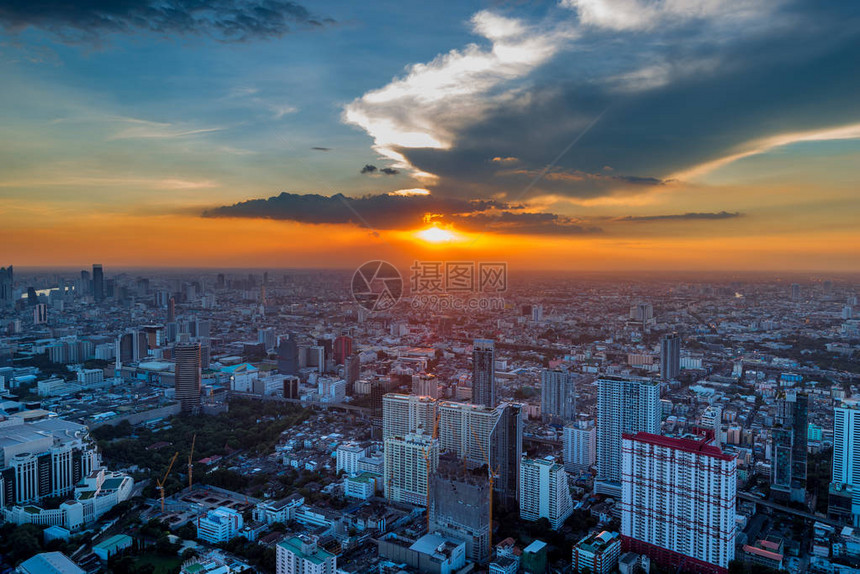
[0, 0, 333, 42]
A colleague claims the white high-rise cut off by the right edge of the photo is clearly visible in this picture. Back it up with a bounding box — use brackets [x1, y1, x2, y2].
[828, 396, 860, 528]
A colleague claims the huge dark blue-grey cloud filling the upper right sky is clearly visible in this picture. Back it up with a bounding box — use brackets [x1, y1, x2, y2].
[396, 2, 860, 198]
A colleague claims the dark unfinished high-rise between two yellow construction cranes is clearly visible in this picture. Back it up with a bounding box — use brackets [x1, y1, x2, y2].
[429, 461, 490, 564]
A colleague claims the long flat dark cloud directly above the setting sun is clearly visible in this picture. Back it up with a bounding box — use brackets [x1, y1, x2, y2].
[203, 192, 600, 235]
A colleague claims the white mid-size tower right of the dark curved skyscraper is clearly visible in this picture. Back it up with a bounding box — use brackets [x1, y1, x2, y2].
[520, 456, 573, 530]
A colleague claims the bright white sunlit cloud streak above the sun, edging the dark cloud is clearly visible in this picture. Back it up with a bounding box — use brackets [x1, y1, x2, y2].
[343, 11, 575, 180]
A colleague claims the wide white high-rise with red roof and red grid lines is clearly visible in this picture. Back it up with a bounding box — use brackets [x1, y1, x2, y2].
[621, 432, 737, 574]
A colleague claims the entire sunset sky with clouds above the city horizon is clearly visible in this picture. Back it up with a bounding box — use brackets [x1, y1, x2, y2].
[0, 0, 860, 272]
